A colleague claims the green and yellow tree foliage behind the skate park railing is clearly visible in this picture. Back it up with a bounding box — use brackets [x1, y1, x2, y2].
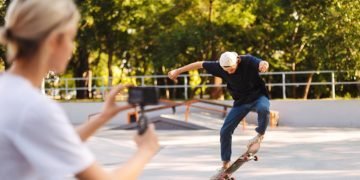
[0, 0, 360, 98]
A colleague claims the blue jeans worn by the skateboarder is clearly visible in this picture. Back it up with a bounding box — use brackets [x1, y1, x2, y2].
[220, 96, 270, 161]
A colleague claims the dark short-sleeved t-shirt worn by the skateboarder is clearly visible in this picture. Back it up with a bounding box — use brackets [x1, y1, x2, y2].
[203, 55, 269, 106]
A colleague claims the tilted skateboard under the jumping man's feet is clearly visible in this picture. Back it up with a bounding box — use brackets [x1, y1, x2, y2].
[212, 143, 260, 180]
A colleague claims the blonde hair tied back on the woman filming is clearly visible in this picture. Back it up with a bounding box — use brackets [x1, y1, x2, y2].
[0, 0, 80, 61]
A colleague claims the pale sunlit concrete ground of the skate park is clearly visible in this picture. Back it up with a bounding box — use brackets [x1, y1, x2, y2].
[88, 126, 360, 180]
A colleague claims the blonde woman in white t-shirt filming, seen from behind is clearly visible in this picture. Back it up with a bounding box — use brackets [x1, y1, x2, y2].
[0, 0, 159, 180]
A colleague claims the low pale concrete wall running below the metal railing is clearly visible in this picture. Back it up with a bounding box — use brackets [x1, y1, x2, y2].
[60, 100, 360, 128]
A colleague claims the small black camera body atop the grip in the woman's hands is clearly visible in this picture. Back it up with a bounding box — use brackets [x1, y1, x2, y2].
[128, 87, 159, 106]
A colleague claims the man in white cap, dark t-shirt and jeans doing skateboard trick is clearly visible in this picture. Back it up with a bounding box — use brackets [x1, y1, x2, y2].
[168, 52, 270, 173]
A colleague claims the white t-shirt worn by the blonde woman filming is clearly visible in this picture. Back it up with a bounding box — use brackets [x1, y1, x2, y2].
[0, 72, 94, 180]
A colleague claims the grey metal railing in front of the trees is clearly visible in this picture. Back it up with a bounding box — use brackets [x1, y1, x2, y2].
[42, 71, 360, 99]
